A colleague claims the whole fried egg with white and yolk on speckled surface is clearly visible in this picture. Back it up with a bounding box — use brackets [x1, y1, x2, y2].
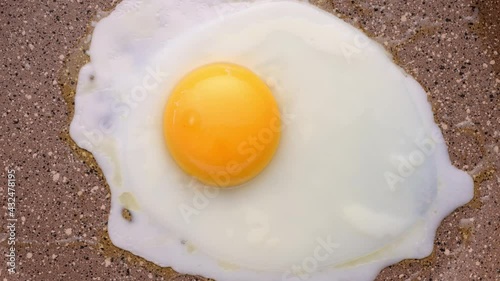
[70, 0, 473, 281]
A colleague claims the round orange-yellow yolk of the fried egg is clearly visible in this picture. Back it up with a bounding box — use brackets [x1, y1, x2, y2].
[163, 63, 281, 187]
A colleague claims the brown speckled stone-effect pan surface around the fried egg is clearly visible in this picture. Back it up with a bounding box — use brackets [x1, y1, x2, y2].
[0, 0, 500, 281]
